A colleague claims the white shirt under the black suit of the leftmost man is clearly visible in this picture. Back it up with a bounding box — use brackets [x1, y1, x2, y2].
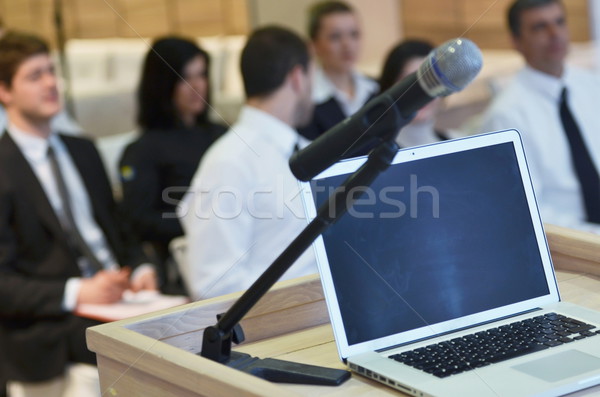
[8, 125, 118, 310]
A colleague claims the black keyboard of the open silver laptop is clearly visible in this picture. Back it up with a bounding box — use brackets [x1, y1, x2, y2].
[389, 313, 600, 378]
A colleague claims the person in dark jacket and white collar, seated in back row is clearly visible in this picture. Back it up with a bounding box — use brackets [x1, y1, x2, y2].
[299, 1, 379, 140]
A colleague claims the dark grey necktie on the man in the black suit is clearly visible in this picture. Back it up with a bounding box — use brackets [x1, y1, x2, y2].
[48, 146, 104, 277]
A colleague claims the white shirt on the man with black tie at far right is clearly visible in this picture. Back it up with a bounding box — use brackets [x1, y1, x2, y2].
[482, 67, 600, 233]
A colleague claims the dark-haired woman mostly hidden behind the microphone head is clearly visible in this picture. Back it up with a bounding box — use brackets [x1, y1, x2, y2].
[379, 40, 449, 147]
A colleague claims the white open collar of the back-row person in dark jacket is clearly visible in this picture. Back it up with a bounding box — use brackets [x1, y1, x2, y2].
[313, 68, 379, 117]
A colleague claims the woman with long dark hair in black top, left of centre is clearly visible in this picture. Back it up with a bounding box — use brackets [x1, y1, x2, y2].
[120, 37, 225, 288]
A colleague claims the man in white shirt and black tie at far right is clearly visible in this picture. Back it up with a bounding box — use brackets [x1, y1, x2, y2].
[482, 0, 600, 233]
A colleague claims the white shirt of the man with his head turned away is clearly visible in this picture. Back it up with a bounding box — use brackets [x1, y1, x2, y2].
[178, 106, 317, 299]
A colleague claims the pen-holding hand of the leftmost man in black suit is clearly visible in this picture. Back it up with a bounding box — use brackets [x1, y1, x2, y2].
[77, 269, 131, 304]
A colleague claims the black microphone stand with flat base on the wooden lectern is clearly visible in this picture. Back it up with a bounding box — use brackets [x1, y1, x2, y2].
[201, 135, 398, 385]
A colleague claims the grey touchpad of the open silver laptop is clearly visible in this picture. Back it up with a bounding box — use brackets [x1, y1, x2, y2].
[512, 350, 600, 382]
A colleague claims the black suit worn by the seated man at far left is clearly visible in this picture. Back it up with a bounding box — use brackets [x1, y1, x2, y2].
[0, 133, 146, 382]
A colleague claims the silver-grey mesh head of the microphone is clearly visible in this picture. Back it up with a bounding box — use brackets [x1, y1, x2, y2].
[417, 38, 483, 97]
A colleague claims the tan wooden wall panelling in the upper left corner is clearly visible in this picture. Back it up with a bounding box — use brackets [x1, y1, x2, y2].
[0, 0, 249, 44]
